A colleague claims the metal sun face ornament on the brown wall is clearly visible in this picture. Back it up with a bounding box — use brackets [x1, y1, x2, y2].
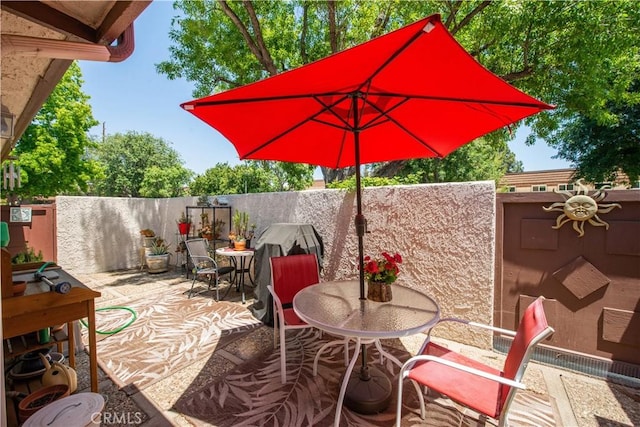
[542, 179, 622, 237]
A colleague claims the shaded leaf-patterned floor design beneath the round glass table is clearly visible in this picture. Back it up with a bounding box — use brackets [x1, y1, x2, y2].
[173, 330, 555, 427]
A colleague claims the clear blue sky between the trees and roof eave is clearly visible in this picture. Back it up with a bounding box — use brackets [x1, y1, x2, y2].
[79, 0, 569, 177]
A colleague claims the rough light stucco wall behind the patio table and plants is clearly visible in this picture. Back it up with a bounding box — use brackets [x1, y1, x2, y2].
[56, 181, 495, 347]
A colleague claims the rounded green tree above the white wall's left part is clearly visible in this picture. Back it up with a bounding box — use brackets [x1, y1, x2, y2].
[95, 131, 193, 197]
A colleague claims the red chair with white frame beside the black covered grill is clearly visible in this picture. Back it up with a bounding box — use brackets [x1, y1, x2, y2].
[267, 253, 348, 384]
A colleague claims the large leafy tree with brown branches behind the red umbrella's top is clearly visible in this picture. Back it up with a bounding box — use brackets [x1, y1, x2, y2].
[157, 0, 640, 181]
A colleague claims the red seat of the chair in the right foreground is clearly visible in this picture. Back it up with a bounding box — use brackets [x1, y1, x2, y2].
[408, 342, 503, 418]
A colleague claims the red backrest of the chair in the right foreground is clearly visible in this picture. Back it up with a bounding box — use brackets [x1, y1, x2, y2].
[499, 296, 554, 408]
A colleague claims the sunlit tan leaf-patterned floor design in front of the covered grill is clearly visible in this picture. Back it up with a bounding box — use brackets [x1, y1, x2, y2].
[83, 292, 262, 390]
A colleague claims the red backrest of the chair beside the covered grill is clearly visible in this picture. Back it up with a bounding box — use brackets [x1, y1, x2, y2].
[269, 254, 320, 305]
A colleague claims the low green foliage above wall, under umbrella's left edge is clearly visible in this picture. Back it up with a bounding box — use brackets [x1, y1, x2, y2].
[190, 161, 314, 195]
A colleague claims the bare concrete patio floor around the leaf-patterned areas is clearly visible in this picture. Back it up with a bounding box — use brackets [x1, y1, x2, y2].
[70, 270, 640, 427]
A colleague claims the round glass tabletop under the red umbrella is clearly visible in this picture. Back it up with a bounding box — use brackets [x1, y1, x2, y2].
[293, 280, 440, 339]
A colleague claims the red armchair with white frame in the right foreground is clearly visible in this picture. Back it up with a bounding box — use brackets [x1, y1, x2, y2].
[396, 296, 554, 427]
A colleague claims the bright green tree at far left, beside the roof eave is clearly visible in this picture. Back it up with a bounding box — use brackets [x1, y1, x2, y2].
[3, 62, 101, 199]
